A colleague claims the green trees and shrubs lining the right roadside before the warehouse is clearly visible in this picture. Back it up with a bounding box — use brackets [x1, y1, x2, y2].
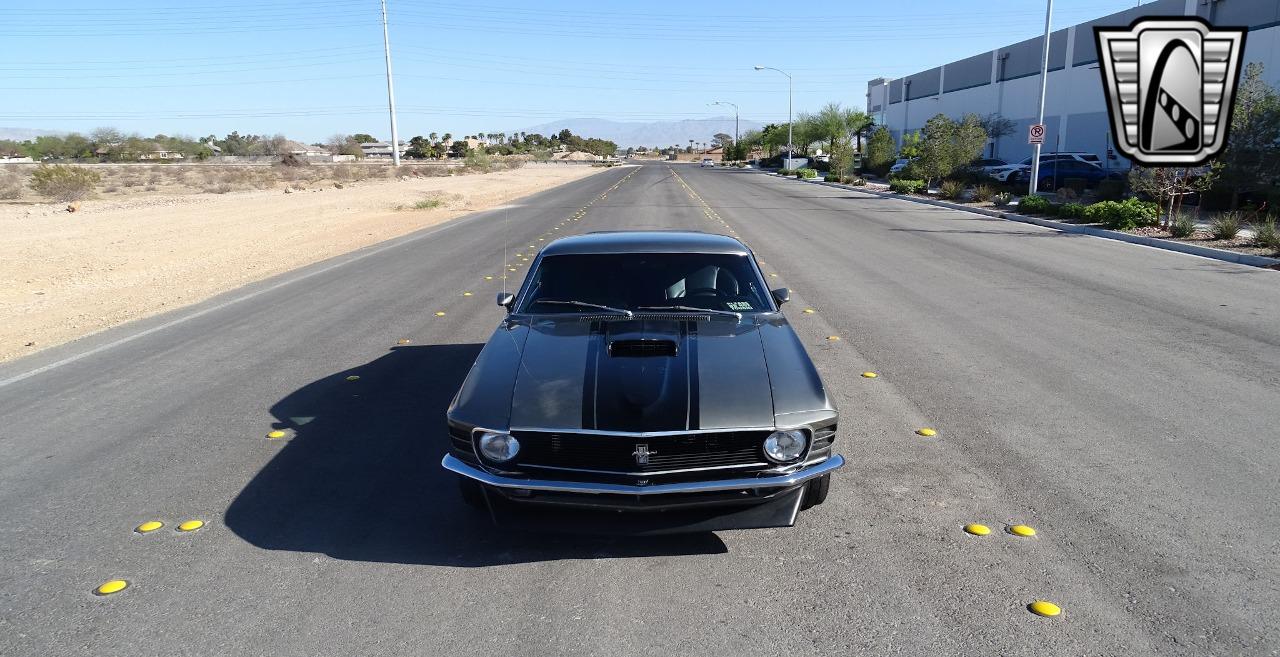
[724, 63, 1280, 255]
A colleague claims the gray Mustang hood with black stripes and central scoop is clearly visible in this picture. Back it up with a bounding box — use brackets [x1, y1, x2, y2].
[449, 315, 835, 432]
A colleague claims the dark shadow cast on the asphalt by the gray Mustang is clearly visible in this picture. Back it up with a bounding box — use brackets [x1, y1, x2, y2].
[224, 345, 727, 567]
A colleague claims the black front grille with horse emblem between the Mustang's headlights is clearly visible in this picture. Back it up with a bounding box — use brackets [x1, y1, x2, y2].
[512, 432, 769, 474]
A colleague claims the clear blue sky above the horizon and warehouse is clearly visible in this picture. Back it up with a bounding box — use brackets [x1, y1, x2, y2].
[0, 0, 1137, 142]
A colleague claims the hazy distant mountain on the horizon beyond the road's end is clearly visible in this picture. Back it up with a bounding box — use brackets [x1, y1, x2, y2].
[524, 117, 763, 149]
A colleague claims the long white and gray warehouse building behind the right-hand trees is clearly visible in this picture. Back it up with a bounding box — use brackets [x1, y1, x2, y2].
[867, 0, 1280, 169]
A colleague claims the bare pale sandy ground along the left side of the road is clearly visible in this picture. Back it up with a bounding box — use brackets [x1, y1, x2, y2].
[0, 164, 605, 361]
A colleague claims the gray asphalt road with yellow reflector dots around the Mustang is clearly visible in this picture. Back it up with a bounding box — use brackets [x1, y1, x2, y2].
[0, 164, 1280, 656]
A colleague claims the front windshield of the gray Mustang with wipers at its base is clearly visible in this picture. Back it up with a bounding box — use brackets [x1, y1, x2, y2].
[518, 254, 773, 314]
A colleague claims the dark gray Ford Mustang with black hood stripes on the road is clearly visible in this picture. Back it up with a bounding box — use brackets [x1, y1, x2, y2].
[443, 232, 845, 533]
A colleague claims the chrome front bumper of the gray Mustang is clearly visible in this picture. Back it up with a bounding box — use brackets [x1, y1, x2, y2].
[440, 453, 845, 496]
